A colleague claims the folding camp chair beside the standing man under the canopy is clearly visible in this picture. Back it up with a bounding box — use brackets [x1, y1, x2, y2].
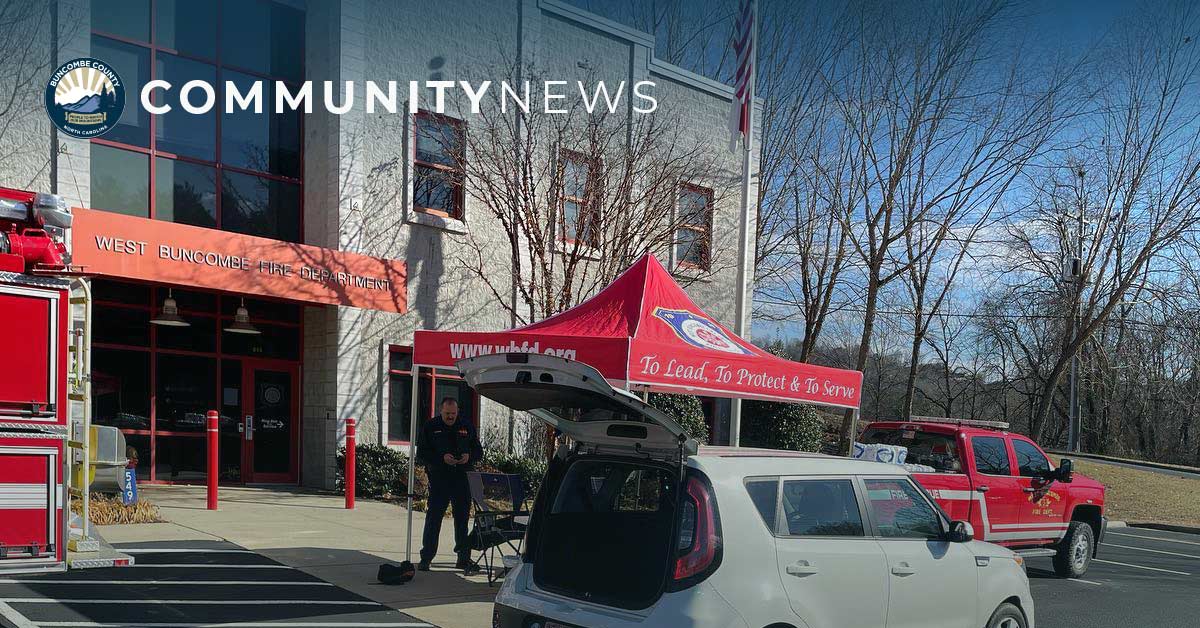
[467, 472, 529, 586]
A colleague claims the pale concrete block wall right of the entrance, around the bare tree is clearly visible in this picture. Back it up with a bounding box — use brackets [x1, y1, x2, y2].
[291, 0, 768, 486]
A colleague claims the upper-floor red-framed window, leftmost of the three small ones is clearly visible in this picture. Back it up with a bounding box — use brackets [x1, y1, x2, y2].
[413, 110, 467, 220]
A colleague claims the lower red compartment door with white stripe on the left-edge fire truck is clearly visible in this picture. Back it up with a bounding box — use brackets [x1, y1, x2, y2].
[0, 447, 60, 559]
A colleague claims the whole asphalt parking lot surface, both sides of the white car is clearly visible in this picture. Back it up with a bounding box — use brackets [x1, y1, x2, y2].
[0, 527, 1200, 628]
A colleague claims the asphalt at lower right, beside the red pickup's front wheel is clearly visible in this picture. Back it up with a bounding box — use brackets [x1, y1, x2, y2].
[1027, 527, 1200, 628]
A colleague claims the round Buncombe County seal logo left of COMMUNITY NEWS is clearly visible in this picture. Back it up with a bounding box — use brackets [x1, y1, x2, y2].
[46, 56, 125, 139]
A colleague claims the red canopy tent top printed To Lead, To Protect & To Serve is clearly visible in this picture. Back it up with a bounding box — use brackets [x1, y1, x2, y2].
[413, 253, 863, 408]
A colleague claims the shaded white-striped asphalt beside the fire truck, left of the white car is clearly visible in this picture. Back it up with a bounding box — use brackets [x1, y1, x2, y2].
[0, 542, 430, 628]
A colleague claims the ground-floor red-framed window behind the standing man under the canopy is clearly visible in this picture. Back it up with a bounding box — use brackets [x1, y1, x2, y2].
[388, 347, 479, 444]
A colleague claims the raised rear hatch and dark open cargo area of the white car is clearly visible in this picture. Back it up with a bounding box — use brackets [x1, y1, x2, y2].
[457, 353, 696, 610]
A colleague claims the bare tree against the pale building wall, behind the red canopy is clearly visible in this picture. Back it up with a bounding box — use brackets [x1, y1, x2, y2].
[456, 66, 734, 323]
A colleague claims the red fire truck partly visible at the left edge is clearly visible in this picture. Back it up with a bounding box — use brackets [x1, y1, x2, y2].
[0, 187, 71, 573]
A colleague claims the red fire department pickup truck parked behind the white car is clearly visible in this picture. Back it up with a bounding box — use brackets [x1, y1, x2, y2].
[859, 417, 1108, 578]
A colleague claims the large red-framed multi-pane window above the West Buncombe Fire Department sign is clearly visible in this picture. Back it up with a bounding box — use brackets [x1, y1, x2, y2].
[90, 0, 305, 241]
